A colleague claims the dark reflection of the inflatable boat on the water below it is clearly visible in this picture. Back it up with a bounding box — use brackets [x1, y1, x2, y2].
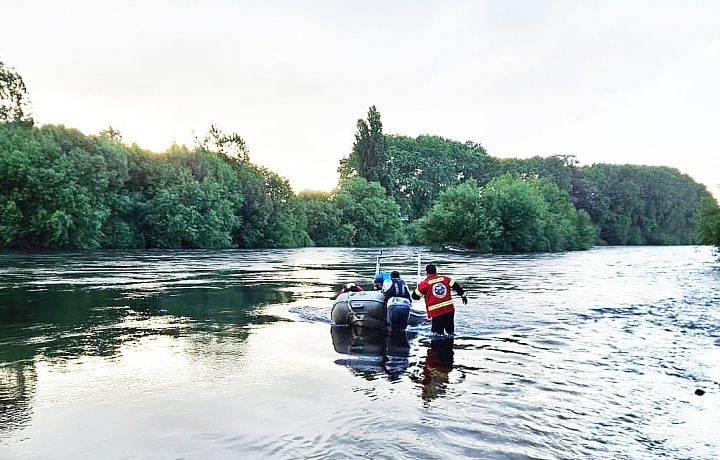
[330, 326, 414, 376]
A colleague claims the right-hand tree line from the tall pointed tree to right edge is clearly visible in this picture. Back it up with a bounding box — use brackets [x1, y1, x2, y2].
[339, 107, 715, 252]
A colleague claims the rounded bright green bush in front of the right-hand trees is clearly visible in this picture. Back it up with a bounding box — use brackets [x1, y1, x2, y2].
[419, 174, 594, 252]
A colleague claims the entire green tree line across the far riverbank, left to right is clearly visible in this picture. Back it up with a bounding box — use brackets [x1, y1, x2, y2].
[0, 63, 718, 252]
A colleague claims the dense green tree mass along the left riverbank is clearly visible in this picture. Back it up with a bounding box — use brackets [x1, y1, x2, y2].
[0, 124, 311, 248]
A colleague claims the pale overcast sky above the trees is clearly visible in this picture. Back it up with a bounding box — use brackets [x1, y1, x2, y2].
[0, 0, 720, 197]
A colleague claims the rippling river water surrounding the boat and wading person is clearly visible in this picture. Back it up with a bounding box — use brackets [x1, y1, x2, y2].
[0, 246, 720, 460]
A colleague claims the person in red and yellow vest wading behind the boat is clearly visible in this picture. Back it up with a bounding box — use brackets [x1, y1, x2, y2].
[412, 264, 467, 335]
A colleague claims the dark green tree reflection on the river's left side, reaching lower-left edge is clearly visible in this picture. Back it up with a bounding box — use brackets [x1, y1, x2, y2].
[0, 253, 291, 439]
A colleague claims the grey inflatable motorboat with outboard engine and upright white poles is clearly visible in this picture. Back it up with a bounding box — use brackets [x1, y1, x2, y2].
[330, 251, 427, 331]
